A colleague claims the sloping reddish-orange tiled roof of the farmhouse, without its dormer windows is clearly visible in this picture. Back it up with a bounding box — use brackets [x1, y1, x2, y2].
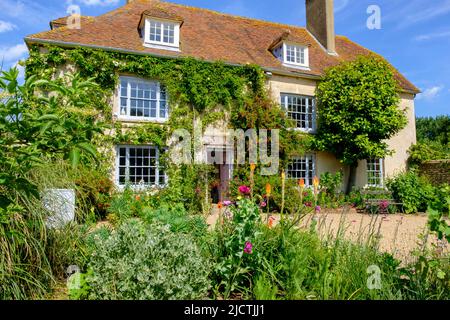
[25, 0, 419, 92]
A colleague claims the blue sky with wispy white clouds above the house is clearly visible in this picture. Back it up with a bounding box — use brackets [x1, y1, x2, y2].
[0, 0, 450, 116]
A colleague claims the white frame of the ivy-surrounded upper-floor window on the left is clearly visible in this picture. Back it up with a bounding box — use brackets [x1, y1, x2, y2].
[117, 76, 170, 123]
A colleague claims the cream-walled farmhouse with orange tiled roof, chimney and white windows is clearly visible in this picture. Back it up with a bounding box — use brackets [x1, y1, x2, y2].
[25, 0, 419, 200]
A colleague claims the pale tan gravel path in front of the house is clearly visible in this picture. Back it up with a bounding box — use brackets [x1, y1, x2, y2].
[207, 209, 450, 263]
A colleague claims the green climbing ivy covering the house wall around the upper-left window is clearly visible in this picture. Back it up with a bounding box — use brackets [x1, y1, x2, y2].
[26, 45, 309, 211]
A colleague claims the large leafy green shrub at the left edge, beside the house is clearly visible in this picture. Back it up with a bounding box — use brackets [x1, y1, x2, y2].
[0, 69, 105, 205]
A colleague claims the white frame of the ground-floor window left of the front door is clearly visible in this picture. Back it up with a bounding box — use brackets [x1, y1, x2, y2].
[114, 144, 169, 190]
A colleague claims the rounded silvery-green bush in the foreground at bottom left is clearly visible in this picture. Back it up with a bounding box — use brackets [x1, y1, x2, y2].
[86, 219, 209, 300]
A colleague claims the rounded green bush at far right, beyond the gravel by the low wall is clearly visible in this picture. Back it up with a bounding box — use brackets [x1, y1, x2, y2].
[386, 170, 435, 213]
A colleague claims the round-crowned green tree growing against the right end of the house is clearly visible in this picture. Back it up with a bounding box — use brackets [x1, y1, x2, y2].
[314, 55, 407, 193]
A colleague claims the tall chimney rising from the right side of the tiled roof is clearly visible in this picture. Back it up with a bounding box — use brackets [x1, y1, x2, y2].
[306, 0, 336, 55]
